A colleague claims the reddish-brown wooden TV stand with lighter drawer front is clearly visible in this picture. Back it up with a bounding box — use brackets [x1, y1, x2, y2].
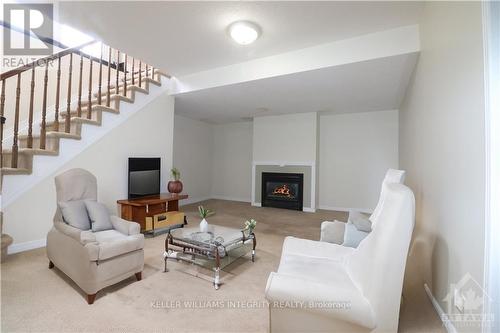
[117, 193, 188, 232]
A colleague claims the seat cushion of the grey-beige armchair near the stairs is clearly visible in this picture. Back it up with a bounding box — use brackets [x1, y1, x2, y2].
[94, 230, 144, 260]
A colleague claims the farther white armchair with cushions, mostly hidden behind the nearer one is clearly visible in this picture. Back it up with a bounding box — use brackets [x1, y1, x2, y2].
[320, 169, 406, 247]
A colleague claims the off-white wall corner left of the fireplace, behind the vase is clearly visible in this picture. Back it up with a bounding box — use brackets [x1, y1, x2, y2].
[174, 115, 253, 204]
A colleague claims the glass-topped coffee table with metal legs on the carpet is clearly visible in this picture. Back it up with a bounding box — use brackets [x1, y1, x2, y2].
[163, 224, 257, 289]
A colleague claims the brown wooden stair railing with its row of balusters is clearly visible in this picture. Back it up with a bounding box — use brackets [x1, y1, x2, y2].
[0, 40, 165, 169]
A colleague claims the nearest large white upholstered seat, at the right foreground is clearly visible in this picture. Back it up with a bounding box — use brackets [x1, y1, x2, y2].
[265, 183, 415, 332]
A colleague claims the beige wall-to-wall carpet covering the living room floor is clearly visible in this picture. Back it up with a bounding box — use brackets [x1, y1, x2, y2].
[1, 200, 444, 332]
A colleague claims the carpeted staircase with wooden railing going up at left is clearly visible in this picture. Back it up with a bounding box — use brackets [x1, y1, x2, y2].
[0, 42, 170, 255]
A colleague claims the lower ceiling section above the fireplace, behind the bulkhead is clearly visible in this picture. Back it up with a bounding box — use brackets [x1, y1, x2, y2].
[175, 53, 418, 123]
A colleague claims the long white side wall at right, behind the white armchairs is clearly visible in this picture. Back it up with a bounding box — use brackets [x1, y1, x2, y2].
[400, 2, 485, 330]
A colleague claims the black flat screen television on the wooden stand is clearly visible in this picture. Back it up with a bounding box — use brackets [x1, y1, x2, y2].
[128, 157, 161, 199]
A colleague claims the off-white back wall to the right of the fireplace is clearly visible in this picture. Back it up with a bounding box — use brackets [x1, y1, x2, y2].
[319, 110, 399, 211]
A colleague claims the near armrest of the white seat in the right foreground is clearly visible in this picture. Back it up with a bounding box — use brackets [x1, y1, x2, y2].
[265, 272, 376, 330]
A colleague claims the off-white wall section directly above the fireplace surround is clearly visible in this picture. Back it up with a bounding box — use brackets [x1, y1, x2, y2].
[253, 112, 317, 162]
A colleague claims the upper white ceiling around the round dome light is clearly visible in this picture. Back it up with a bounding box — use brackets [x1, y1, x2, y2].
[59, 1, 422, 77]
